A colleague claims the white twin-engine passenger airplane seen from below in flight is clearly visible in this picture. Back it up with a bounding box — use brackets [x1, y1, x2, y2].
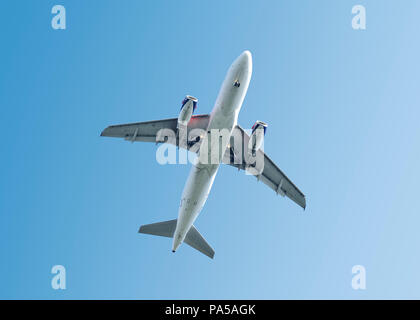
[101, 51, 306, 259]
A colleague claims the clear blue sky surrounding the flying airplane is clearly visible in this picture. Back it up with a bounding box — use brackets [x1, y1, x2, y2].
[0, 0, 420, 299]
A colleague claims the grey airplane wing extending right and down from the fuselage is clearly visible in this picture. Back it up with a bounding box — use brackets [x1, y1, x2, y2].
[223, 125, 306, 209]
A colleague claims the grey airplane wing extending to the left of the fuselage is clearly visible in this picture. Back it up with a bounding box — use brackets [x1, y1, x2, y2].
[101, 114, 210, 151]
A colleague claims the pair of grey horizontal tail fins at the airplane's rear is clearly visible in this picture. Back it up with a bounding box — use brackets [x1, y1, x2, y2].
[139, 219, 214, 259]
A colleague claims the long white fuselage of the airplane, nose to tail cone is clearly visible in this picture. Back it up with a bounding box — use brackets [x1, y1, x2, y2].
[172, 51, 252, 251]
